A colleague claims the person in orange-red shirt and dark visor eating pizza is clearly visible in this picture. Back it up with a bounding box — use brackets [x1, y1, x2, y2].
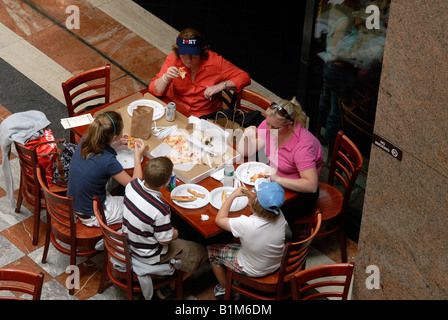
[149, 28, 251, 117]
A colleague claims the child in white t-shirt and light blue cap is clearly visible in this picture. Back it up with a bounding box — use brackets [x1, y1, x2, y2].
[207, 182, 287, 299]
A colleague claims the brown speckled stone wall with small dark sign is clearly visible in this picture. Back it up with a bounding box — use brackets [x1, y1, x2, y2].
[353, 0, 448, 300]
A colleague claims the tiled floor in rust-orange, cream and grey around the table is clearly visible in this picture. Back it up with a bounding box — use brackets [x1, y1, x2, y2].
[0, 0, 357, 300]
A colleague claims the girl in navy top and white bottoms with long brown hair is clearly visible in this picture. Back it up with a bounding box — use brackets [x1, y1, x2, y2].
[67, 111, 145, 227]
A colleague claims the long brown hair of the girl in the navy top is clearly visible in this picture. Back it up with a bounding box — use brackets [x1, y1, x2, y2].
[81, 111, 123, 159]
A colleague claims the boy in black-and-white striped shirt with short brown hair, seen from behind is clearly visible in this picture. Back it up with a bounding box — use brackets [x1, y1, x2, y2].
[123, 157, 207, 298]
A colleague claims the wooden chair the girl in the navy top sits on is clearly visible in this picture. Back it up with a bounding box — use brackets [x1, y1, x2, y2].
[36, 165, 102, 295]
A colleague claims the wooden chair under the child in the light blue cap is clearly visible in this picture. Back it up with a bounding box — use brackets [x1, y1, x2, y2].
[224, 210, 322, 300]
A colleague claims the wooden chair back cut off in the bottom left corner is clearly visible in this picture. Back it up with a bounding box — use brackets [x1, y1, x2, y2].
[0, 268, 44, 300]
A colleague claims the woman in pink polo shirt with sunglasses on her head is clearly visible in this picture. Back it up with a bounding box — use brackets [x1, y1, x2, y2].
[238, 98, 323, 227]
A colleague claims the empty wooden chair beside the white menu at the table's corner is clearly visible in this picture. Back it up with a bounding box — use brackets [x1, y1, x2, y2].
[62, 64, 110, 143]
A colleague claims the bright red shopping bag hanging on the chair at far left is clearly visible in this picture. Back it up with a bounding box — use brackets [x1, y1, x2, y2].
[25, 129, 58, 187]
